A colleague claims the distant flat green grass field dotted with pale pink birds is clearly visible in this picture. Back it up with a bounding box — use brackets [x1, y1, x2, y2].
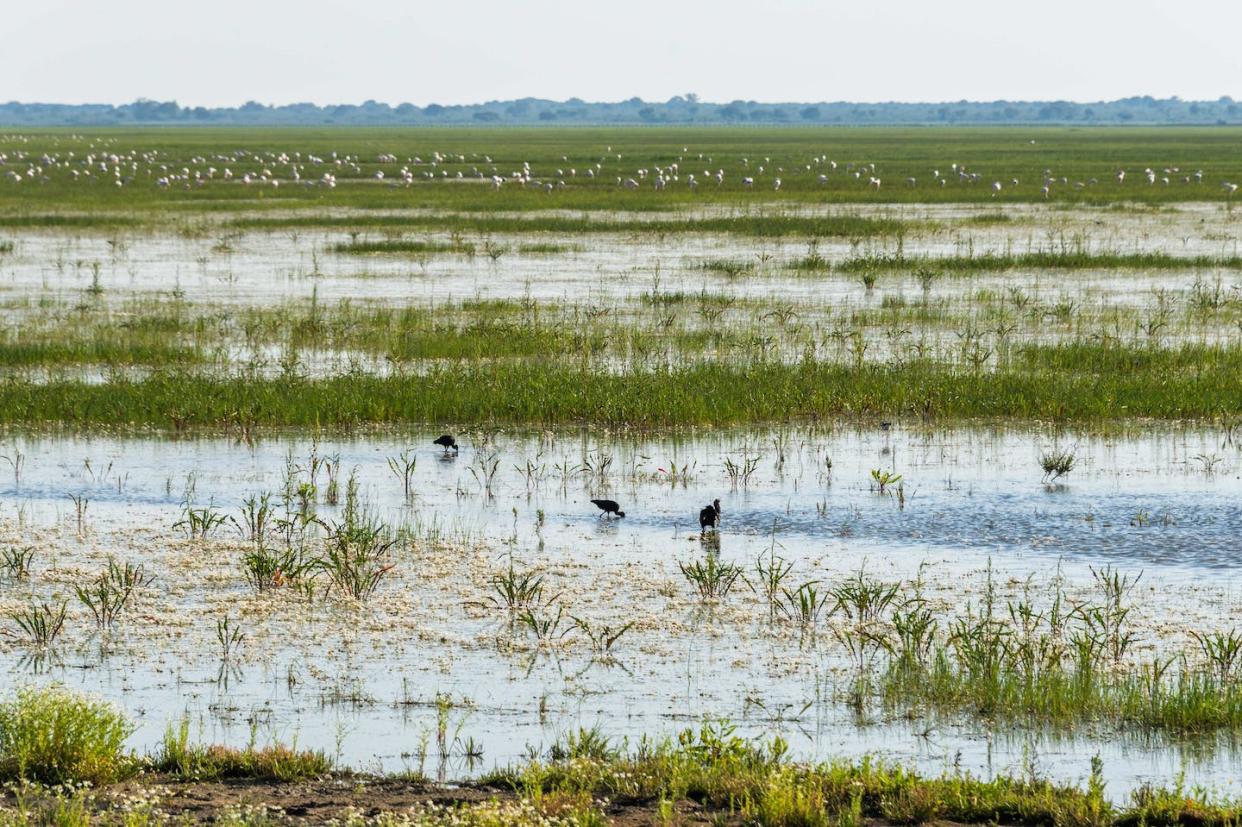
[7, 127, 1242, 217]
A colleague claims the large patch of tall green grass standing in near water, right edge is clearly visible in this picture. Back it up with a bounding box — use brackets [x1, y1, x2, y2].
[835, 566, 1242, 738]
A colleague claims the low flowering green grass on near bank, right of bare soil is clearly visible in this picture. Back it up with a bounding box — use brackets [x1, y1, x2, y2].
[489, 723, 1172, 827]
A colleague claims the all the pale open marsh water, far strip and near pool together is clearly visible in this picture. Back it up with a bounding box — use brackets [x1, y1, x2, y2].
[0, 196, 1242, 798]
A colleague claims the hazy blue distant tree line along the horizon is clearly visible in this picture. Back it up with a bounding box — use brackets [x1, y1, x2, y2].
[0, 94, 1242, 127]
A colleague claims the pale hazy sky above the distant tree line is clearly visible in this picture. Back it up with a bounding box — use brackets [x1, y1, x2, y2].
[9, 0, 1242, 106]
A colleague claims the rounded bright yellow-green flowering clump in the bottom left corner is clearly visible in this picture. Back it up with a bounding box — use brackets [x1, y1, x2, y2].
[0, 684, 135, 784]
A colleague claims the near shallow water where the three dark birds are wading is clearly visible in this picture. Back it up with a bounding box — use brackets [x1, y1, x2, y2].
[0, 427, 1242, 796]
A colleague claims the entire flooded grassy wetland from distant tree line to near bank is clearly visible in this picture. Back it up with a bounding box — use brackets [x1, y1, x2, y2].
[0, 129, 1242, 823]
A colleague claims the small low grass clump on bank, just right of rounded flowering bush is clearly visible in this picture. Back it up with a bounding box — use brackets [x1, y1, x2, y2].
[152, 719, 333, 781]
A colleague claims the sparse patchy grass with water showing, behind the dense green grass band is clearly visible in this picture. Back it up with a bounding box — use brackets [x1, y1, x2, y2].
[9, 283, 1242, 380]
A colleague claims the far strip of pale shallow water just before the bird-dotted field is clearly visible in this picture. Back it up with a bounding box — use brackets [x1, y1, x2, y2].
[0, 204, 1238, 305]
